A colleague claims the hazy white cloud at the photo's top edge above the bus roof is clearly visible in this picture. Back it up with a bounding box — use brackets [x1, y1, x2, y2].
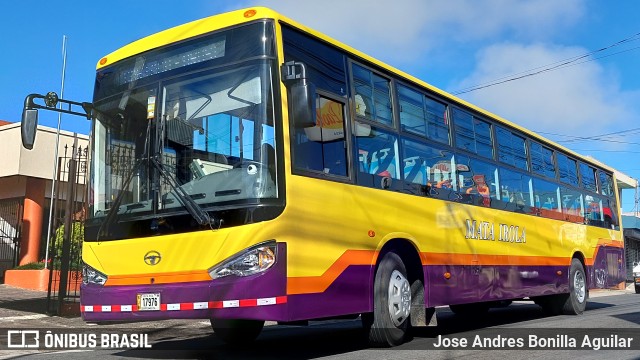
[238, 0, 584, 63]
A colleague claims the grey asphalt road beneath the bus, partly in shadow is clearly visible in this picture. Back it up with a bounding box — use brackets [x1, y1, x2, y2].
[5, 294, 640, 360]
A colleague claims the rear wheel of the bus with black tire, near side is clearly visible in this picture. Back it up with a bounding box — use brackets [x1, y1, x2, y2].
[535, 259, 588, 315]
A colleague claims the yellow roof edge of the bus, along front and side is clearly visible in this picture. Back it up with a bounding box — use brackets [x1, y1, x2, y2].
[96, 7, 615, 173]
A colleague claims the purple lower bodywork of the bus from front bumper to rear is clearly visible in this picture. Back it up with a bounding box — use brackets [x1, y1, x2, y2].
[81, 245, 621, 321]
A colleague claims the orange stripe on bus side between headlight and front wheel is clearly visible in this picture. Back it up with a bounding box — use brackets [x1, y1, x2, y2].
[287, 250, 378, 294]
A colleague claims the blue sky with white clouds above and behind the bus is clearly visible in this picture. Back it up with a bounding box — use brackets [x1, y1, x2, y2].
[0, 0, 640, 211]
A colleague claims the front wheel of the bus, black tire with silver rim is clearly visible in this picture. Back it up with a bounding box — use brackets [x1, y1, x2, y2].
[362, 253, 411, 347]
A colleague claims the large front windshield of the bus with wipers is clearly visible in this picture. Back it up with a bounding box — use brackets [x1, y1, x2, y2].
[89, 23, 278, 231]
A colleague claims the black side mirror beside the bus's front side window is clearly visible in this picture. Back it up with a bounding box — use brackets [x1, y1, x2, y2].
[282, 61, 316, 128]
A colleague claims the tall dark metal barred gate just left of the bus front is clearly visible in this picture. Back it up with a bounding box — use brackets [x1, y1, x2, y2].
[47, 142, 88, 315]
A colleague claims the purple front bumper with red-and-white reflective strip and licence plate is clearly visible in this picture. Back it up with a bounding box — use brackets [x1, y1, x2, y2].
[80, 244, 287, 322]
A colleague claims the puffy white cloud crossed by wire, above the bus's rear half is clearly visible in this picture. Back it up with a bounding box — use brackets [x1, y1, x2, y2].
[453, 43, 636, 136]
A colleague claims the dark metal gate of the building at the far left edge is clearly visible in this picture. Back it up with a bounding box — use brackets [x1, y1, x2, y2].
[0, 198, 24, 281]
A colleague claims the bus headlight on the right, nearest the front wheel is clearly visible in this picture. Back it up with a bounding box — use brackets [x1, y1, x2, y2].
[209, 241, 276, 279]
